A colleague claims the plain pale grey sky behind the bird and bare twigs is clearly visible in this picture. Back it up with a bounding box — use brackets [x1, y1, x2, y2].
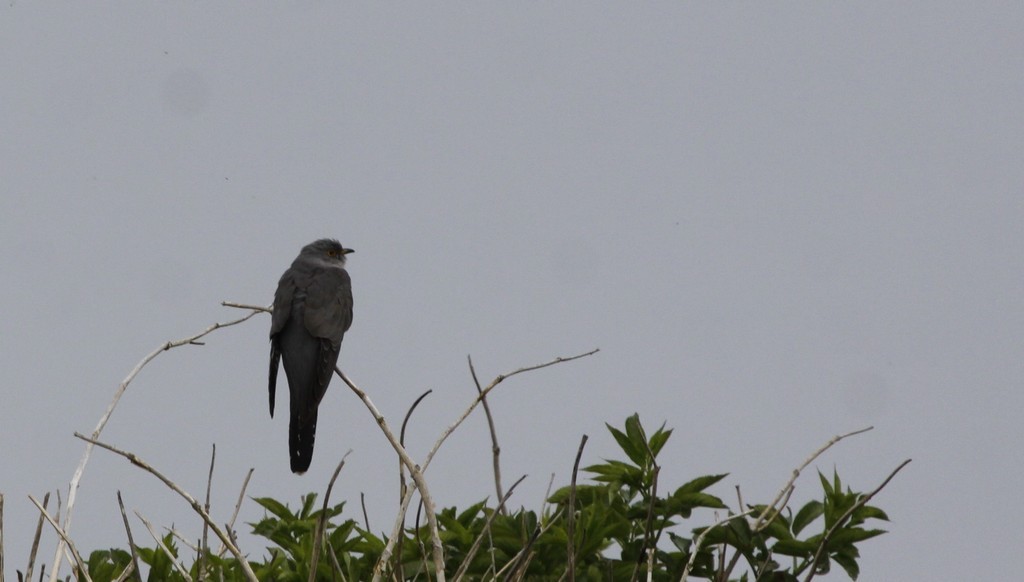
[0, 1, 1024, 581]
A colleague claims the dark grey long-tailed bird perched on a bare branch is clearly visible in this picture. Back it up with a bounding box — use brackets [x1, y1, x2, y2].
[270, 239, 354, 474]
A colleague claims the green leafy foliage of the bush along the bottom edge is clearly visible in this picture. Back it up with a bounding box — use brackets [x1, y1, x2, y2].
[72, 414, 888, 582]
